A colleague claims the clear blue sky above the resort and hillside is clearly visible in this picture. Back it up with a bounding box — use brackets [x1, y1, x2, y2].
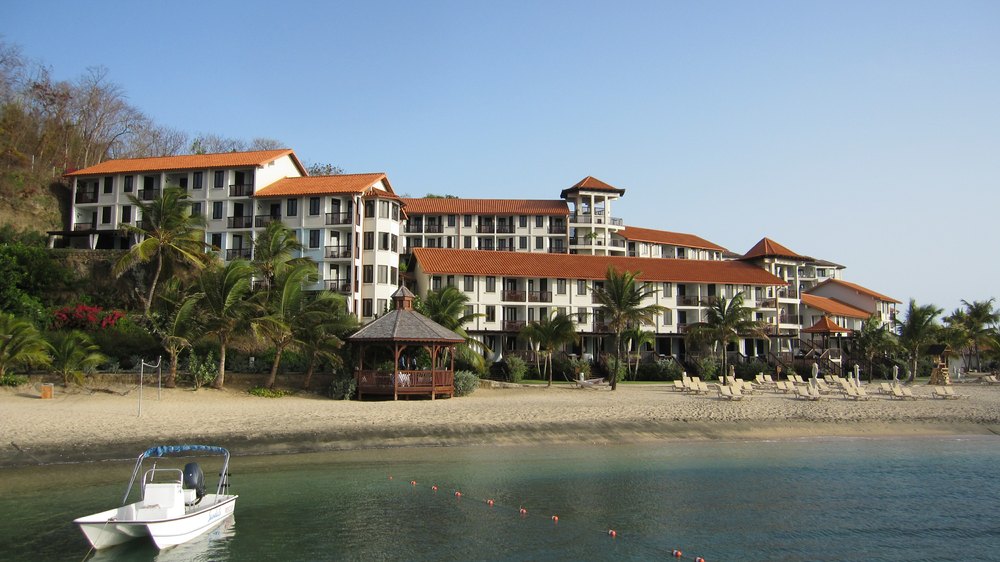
[0, 0, 1000, 313]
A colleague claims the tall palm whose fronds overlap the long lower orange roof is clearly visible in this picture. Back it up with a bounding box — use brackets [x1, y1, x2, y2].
[593, 266, 666, 390]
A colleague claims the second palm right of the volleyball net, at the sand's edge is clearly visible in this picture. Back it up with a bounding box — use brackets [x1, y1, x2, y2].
[198, 260, 254, 389]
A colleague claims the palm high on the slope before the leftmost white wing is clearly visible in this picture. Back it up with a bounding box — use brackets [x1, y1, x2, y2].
[113, 187, 208, 316]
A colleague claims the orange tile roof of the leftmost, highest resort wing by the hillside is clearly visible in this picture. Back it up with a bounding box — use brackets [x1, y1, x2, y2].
[66, 148, 307, 176]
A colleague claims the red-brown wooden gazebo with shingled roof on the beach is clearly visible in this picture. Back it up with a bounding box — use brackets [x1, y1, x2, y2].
[347, 287, 465, 400]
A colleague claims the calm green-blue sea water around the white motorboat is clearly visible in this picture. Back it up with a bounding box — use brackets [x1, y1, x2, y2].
[0, 437, 1000, 562]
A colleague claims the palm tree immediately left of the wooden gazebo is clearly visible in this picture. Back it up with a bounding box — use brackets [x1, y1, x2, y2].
[292, 292, 358, 390]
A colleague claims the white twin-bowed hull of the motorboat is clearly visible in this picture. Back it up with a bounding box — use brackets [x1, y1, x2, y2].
[74, 494, 239, 550]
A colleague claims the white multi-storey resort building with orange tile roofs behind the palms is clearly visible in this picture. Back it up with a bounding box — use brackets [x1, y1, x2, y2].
[50, 149, 899, 366]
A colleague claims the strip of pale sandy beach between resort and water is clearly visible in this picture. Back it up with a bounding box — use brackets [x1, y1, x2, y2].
[0, 380, 1000, 466]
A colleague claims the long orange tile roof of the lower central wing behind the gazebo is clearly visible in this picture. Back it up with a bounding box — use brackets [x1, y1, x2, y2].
[413, 248, 785, 285]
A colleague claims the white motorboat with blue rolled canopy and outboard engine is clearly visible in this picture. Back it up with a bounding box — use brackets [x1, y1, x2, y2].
[73, 445, 239, 549]
